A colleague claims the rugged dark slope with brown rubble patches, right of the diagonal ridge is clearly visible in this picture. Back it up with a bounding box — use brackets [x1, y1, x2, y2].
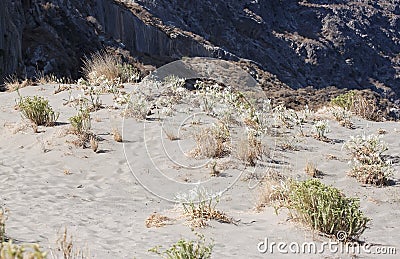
[133, 0, 400, 97]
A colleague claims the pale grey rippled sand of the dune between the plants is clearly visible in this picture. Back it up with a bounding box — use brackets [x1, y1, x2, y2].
[0, 85, 400, 258]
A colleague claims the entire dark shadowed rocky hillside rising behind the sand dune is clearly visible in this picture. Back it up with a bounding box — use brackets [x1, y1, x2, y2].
[0, 0, 400, 99]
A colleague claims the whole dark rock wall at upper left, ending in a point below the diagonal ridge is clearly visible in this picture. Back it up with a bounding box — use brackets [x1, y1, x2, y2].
[0, 0, 235, 84]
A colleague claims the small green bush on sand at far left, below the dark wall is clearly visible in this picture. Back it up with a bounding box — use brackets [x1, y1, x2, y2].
[17, 93, 59, 126]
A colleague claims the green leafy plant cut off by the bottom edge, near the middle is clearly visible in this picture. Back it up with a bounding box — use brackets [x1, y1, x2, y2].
[149, 233, 214, 259]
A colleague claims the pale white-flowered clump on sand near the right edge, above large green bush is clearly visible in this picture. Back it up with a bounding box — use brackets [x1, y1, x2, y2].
[344, 135, 393, 186]
